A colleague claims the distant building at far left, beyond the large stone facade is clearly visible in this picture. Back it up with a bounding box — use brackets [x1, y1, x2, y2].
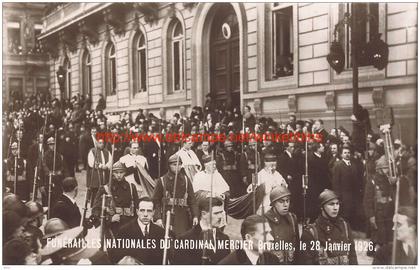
[2, 3, 50, 108]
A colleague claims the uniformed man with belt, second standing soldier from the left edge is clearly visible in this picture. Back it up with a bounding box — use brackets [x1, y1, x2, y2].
[40, 137, 64, 205]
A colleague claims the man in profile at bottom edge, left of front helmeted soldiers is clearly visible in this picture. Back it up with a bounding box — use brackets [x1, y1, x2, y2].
[219, 215, 280, 265]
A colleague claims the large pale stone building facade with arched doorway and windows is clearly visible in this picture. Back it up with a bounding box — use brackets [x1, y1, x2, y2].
[40, 3, 417, 143]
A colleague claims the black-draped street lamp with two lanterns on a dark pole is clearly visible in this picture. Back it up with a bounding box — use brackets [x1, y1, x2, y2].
[327, 4, 388, 114]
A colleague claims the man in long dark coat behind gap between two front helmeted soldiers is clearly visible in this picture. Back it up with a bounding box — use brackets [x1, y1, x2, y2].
[306, 142, 331, 221]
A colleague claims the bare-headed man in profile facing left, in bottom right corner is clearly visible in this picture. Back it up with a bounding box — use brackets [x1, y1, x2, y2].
[373, 206, 418, 265]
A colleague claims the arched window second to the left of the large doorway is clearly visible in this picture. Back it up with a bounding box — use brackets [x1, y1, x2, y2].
[133, 32, 147, 94]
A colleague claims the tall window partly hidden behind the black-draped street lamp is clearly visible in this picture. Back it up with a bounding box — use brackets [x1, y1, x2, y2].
[339, 3, 379, 69]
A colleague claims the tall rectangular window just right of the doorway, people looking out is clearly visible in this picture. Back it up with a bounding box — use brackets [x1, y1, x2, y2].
[271, 3, 294, 79]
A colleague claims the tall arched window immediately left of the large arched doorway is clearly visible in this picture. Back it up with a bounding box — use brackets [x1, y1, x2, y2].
[169, 20, 184, 93]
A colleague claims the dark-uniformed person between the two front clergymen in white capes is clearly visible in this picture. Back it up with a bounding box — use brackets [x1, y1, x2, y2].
[217, 140, 246, 198]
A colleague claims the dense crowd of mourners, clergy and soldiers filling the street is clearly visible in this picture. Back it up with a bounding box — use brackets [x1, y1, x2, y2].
[3, 92, 417, 264]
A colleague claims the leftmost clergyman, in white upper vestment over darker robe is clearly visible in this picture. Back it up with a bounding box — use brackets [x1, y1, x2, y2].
[86, 138, 112, 205]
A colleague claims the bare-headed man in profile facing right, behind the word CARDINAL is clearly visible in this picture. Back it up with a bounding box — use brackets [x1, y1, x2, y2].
[174, 197, 230, 265]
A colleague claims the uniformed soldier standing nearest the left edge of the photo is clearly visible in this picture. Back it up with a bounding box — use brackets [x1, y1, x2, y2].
[5, 142, 29, 200]
